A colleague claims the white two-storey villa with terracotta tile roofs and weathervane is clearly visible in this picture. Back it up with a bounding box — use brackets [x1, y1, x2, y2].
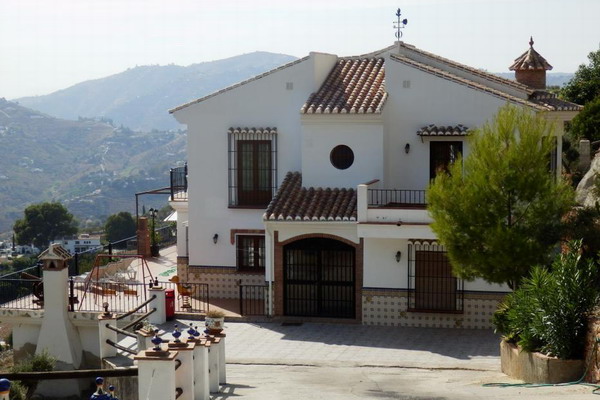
[171, 41, 581, 328]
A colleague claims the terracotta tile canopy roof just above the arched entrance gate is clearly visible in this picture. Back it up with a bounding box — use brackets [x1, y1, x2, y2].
[263, 172, 356, 221]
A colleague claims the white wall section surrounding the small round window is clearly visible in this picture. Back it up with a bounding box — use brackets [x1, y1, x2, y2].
[302, 115, 383, 188]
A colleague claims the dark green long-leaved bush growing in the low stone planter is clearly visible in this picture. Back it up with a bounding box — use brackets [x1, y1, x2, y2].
[493, 241, 598, 359]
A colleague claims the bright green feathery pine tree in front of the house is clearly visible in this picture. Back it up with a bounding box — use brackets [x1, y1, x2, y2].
[428, 105, 573, 288]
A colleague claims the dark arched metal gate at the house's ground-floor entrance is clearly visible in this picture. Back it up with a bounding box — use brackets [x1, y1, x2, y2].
[283, 238, 356, 318]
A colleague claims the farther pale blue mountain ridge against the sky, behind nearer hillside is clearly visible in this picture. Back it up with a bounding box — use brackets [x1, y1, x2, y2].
[16, 52, 296, 131]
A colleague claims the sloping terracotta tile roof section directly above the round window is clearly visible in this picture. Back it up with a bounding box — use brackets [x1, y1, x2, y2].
[300, 58, 387, 114]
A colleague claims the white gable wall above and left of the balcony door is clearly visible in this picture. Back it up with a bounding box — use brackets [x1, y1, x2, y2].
[380, 59, 505, 190]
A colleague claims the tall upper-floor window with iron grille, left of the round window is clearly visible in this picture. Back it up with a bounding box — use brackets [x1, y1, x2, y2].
[228, 128, 277, 208]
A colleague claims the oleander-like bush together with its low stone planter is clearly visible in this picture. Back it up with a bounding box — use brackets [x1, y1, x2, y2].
[493, 241, 598, 383]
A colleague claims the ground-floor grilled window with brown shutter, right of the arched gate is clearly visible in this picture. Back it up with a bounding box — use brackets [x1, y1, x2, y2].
[408, 242, 464, 313]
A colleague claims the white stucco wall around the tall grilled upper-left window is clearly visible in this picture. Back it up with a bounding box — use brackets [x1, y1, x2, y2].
[175, 53, 337, 266]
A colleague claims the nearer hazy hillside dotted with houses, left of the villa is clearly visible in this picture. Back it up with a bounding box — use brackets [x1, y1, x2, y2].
[0, 98, 186, 232]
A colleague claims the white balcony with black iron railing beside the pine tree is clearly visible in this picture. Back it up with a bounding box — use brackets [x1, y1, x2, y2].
[357, 180, 435, 239]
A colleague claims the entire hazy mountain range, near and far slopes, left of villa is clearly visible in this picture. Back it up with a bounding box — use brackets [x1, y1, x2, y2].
[0, 52, 295, 232]
